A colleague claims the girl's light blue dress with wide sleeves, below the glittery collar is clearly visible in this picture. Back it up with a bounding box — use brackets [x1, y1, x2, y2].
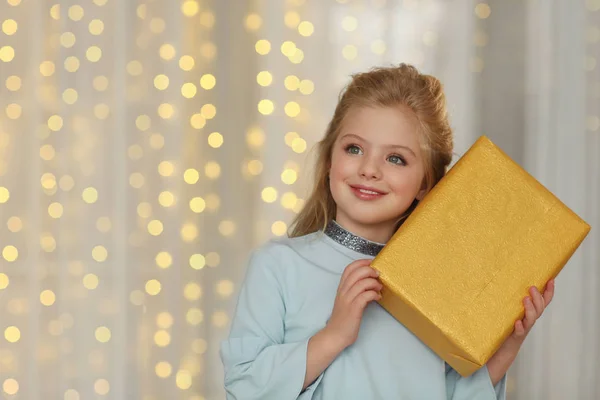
[220, 231, 506, 400]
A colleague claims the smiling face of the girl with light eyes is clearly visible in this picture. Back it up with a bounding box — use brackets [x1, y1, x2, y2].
[329, 107, 425, 243]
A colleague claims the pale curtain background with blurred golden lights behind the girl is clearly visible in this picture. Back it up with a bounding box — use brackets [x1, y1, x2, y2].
[0, 0, 600, 400]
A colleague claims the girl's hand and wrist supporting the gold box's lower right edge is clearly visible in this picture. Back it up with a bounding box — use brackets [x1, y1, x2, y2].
[487, 279, 554, 385]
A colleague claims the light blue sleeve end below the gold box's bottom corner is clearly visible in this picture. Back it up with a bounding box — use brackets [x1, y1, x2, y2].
[446, 364, 506, 400]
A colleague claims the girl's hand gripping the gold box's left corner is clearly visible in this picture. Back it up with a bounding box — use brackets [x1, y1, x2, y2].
[324, 260, 383, 350]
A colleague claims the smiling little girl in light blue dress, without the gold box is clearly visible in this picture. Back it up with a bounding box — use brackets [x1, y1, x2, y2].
[220, 64, 554, 400]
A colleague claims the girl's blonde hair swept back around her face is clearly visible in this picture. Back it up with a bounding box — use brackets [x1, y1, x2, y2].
[289, 64, 453, 237]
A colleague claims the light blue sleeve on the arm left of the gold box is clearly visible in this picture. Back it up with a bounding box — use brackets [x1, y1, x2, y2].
[220, 250, 323, 400]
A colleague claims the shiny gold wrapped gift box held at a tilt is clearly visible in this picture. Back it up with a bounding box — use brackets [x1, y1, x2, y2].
[372, 136, 590, 377]
